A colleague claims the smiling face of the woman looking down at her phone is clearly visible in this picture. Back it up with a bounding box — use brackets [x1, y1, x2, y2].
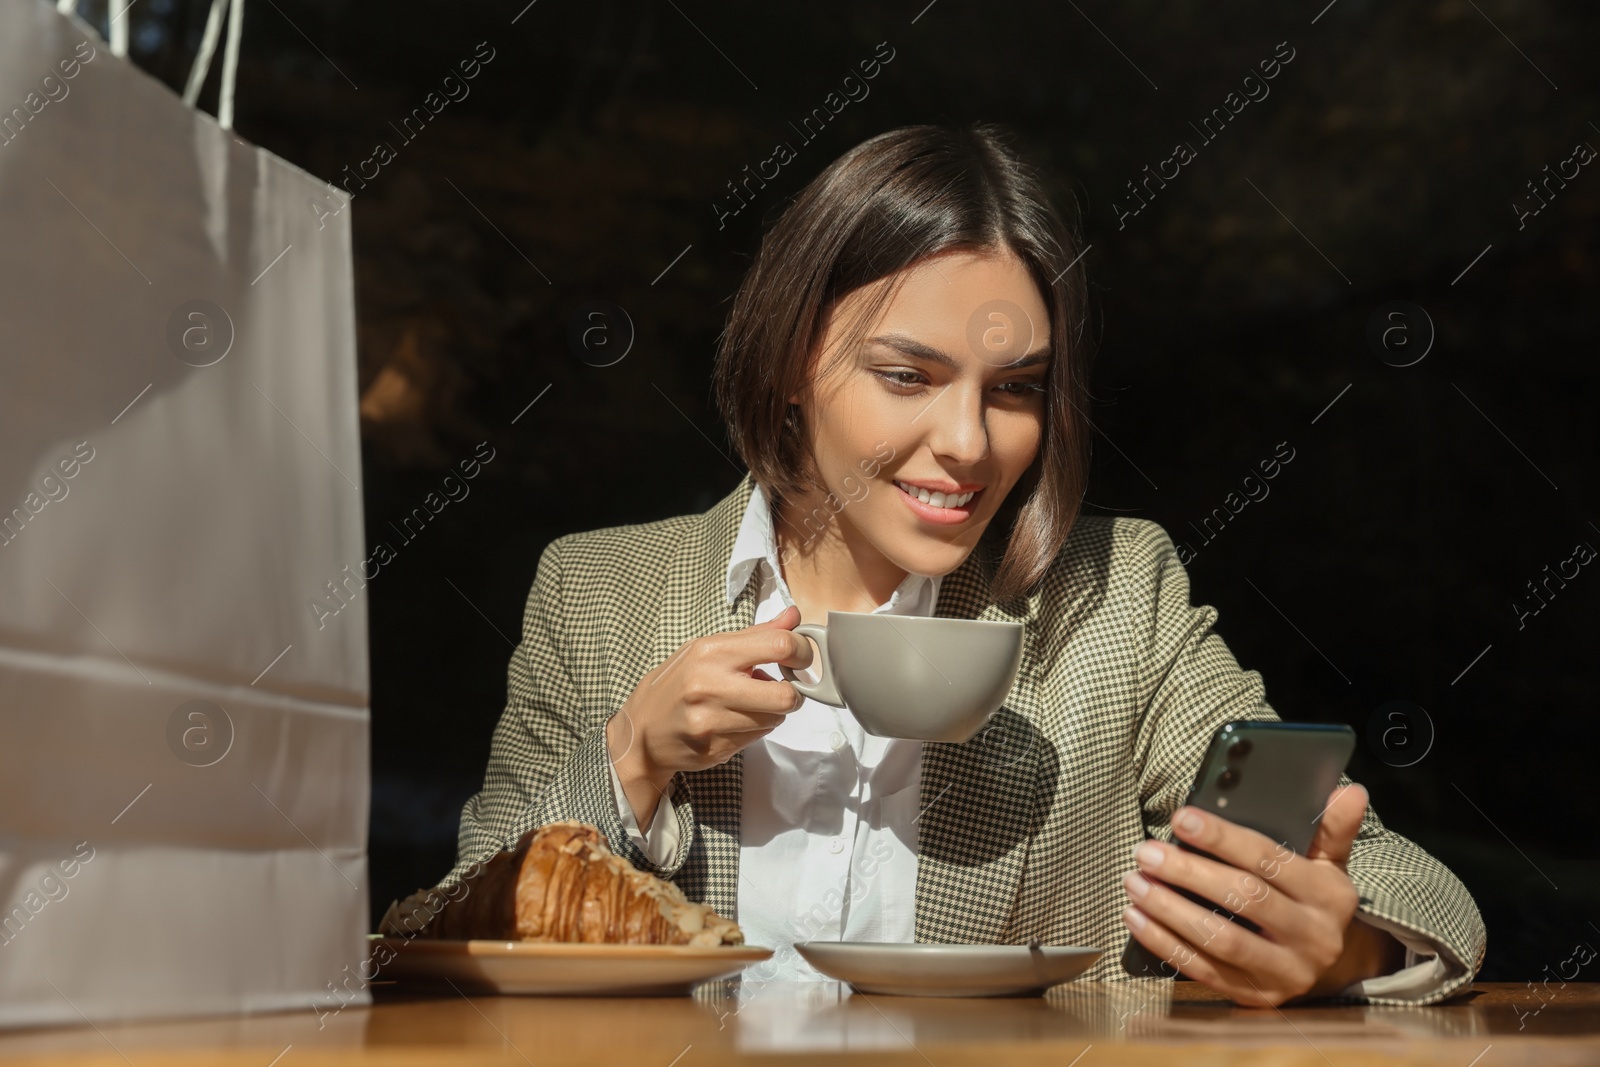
[789, 251, 1050, 576]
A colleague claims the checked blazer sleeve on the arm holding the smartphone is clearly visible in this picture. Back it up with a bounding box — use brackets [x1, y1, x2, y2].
[1125, 522, 1486, 1005]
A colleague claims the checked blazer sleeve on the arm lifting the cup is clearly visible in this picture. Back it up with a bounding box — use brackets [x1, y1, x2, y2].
[440, 537, 694, 886]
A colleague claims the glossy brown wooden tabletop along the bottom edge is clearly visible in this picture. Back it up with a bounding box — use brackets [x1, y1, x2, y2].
[0, 979, 1600, 1067]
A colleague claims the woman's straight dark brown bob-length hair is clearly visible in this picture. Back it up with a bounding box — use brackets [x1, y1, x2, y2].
[714, 123, 1091, 600]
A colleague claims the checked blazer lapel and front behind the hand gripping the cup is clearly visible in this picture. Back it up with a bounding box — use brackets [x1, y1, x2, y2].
[650, 474, 760, 921]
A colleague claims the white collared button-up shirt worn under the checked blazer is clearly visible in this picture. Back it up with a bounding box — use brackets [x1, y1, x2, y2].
[611, 485, 941, 981]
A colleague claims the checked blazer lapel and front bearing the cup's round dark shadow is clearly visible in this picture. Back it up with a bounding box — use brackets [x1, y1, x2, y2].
[917, 550, 1059, 944]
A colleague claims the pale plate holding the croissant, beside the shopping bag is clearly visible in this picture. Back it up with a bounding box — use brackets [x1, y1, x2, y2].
[371, 934, 773, 997]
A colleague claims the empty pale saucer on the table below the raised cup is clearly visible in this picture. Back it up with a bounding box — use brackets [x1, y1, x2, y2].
[795, 941, 1102, 997]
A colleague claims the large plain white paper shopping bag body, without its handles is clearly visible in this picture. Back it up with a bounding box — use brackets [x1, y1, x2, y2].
[0, 0, 370, 1025]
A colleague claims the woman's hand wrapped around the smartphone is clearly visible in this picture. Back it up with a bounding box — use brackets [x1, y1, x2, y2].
[1122, 785, 1405, 1008]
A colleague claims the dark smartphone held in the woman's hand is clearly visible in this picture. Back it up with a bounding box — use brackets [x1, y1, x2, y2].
[1122, 720, 1355, 977]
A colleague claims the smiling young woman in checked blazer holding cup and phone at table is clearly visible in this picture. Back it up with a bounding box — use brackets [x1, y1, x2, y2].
[442, 126, 1485, 1005]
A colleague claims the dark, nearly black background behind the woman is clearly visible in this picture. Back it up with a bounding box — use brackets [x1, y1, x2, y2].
[96, 0, 1600, 981]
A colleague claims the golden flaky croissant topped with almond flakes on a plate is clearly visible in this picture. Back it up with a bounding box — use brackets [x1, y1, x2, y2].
[379, 821, 744, 945]
